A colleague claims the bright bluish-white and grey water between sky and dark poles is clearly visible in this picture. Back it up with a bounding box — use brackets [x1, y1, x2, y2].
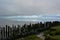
[0, 15, 60, 25]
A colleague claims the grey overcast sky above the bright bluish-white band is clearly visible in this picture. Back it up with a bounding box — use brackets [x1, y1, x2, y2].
[0, 0, 60, 15]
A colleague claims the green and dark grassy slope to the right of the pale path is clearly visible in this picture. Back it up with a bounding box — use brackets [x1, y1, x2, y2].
[46, 26, 60, 40]
